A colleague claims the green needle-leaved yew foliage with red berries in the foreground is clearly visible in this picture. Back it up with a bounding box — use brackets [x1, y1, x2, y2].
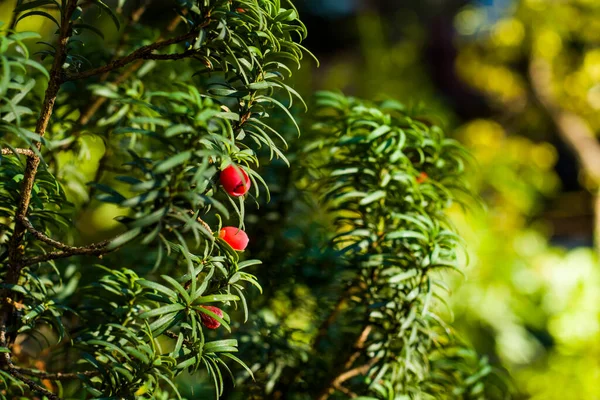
[0, 0, 504, 399]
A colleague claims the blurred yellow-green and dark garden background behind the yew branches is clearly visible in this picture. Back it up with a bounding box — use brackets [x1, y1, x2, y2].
[0, 0, 600, 400]
